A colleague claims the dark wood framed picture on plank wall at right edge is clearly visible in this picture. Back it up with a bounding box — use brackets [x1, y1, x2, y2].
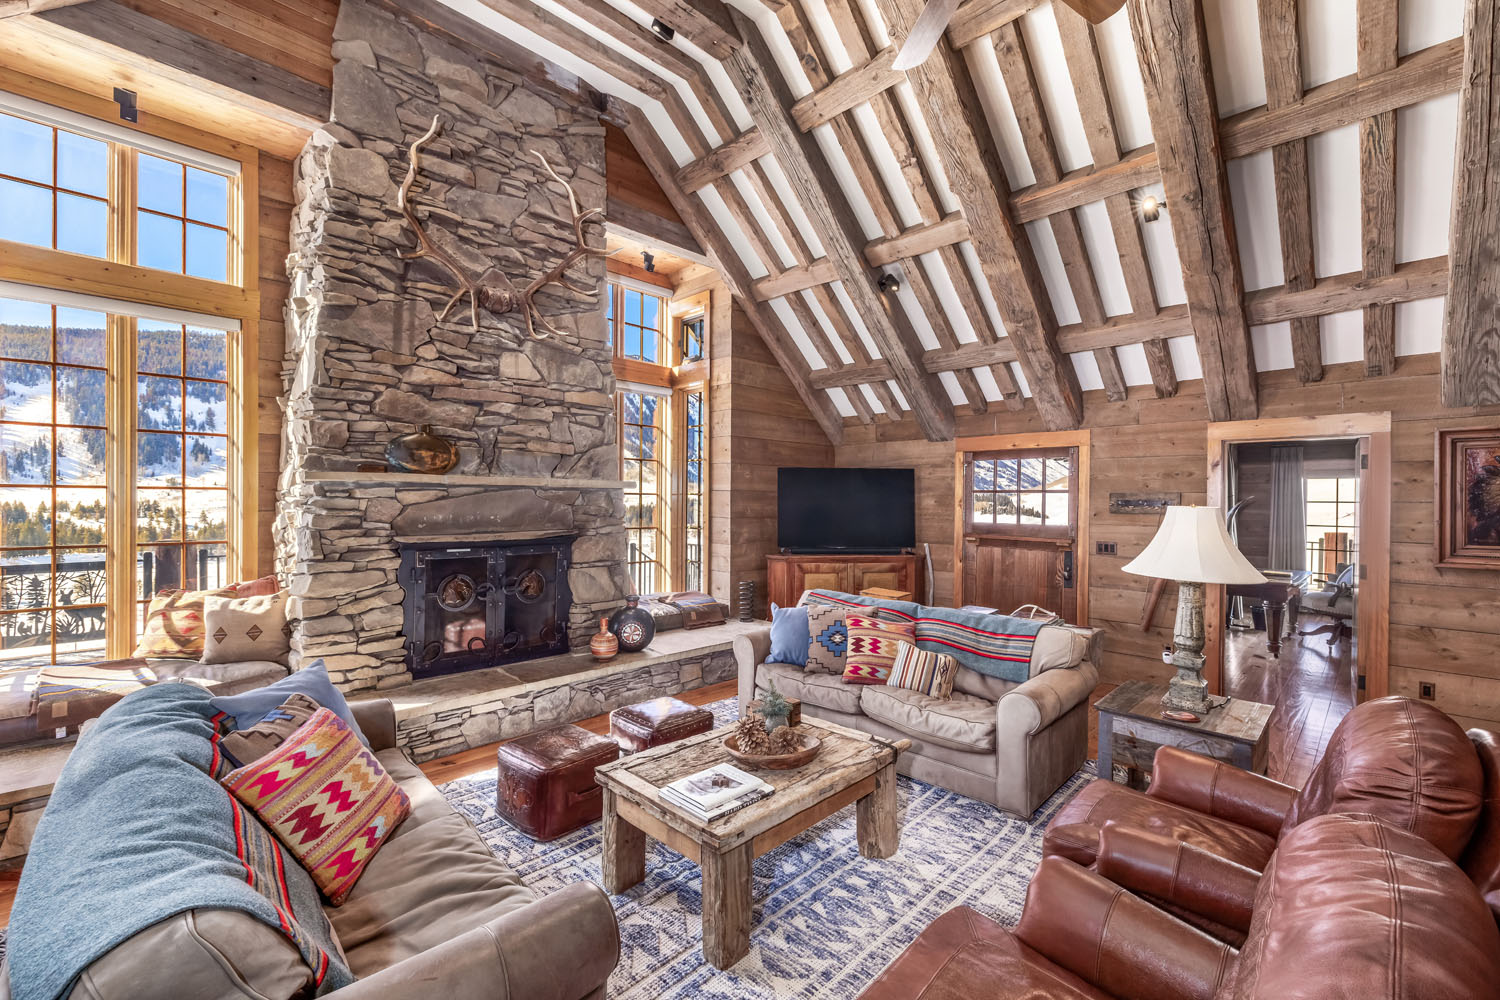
[1434, 427, 1500, 570]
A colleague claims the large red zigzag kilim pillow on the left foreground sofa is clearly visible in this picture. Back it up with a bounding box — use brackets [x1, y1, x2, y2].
[224, 708, 411, 906]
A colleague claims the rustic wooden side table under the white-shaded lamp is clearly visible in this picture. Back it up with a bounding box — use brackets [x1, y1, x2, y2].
[1094, 681, 1274, 784]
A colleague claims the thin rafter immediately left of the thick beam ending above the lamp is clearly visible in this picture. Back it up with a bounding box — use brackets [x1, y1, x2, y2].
[1053, 3, 1178, 399]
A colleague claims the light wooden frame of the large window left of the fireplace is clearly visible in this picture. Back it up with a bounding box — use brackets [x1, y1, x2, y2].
[0, 73, 261, 658]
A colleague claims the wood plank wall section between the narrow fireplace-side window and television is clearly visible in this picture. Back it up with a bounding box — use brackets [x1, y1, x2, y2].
[708, 285, 840, 618]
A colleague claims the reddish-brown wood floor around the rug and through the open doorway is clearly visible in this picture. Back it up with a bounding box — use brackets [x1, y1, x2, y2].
[0, 644, 1353, 927]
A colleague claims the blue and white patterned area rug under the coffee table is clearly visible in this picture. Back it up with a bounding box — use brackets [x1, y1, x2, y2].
[443, 700, 1094, 1000]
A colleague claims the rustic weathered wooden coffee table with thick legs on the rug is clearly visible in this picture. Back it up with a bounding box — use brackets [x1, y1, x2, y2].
[594, 720, 912, 969]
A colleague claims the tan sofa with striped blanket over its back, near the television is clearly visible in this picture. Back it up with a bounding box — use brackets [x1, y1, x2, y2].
[734, 599, 1100, 817]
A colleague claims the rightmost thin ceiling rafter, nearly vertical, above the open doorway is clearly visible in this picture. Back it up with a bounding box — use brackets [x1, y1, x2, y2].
[1356, 0, 1398, 375]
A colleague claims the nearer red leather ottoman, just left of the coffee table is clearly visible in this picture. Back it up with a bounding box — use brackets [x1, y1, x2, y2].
[495, 726, 620, 841]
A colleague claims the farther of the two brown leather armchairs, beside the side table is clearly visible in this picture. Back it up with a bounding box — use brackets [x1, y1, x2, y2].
[1043, 697, 1485, 871]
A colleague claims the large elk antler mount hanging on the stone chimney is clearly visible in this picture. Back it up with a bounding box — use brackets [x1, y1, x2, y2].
[396, 115, 609, 340]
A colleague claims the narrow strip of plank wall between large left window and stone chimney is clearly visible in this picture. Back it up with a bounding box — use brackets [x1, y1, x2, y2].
[255, 153, 294, 576]
